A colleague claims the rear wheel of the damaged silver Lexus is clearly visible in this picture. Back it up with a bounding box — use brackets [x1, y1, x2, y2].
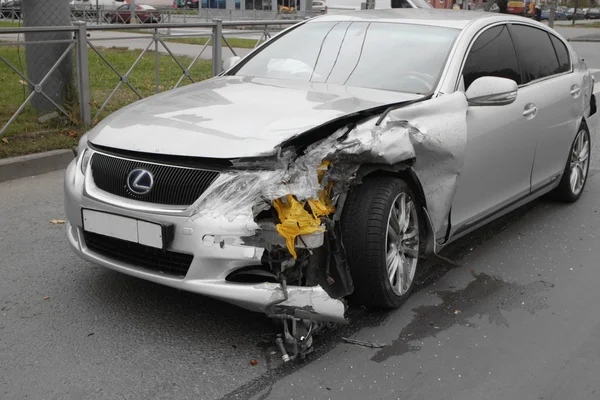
[553, 124, 591, 203]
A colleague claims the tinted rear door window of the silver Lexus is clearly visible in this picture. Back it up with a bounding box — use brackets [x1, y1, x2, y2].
[510, 25, 560, 83]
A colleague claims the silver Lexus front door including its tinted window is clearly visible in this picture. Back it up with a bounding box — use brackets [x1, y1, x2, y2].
[451, 24, 539, 235]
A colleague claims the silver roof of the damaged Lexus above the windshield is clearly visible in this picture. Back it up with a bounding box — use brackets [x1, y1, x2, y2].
[308, 8, 524, 30]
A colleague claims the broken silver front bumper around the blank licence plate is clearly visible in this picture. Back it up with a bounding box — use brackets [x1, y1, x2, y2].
[64, 159, 346, 323]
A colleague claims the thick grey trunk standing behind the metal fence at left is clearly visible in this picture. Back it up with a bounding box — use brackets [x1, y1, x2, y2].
[22, 0, 73, 111]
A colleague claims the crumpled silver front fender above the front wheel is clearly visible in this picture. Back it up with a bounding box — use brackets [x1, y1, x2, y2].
[197, 93, 467, 250]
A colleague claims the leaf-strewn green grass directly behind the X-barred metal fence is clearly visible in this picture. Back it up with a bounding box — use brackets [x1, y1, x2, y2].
[0, 46, 212, 158]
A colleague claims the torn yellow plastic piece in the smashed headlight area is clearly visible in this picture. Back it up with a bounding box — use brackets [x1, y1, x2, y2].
[273, 161, 335, 259]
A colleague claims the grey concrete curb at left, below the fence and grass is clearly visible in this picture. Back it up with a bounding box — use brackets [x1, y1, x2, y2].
[0, 150, 73, 182]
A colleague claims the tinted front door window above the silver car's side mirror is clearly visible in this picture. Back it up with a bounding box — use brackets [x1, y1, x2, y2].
[463, 25, 521, 90]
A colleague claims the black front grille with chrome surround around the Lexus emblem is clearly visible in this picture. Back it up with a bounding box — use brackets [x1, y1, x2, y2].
[90, 153, 219, 206]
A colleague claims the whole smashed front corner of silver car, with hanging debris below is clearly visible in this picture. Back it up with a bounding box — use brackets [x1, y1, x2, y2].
[192, 95, 466, 361]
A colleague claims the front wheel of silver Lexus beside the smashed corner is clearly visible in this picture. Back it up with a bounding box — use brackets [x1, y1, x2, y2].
[341, 176, 426, 308]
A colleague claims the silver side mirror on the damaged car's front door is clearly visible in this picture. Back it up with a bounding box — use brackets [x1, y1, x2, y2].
[465, 76, 519, 106]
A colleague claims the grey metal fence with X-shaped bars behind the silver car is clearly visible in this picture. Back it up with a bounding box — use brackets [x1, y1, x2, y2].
[0, 20, 297, 137]
